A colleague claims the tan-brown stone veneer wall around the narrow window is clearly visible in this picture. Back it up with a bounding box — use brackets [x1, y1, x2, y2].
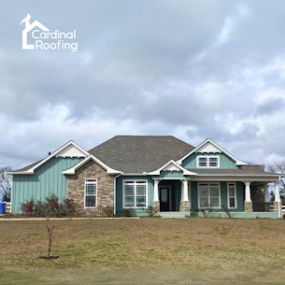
[67, 160, 114, 216]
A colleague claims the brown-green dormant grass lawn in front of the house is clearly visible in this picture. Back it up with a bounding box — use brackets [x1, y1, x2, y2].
[0, 218, 285, 285]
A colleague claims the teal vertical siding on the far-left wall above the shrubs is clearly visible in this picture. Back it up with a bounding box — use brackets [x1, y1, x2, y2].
[12, 157, 82, 214]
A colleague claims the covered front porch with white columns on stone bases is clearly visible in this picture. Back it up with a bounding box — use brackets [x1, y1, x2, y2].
[153, 178, 282, 218]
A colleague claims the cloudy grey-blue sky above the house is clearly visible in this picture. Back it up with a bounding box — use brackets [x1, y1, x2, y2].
[0, 0, 285, 169]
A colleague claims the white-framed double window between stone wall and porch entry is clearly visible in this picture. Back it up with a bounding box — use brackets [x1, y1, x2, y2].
[123, 180, 147, 208]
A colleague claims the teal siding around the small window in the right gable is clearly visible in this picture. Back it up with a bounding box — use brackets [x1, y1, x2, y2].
[182, 153, 238, 169]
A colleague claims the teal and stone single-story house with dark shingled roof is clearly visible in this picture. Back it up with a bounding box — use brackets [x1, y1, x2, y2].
[7, 136, 281, 218]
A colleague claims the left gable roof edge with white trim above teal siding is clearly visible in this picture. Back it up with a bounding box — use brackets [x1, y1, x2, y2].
[7, 141, 89, 175]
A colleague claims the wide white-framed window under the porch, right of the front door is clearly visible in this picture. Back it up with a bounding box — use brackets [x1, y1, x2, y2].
[198, 183, 221, 209]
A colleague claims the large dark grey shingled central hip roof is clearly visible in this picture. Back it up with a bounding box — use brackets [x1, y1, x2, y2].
[89, 136, 194, 174]
